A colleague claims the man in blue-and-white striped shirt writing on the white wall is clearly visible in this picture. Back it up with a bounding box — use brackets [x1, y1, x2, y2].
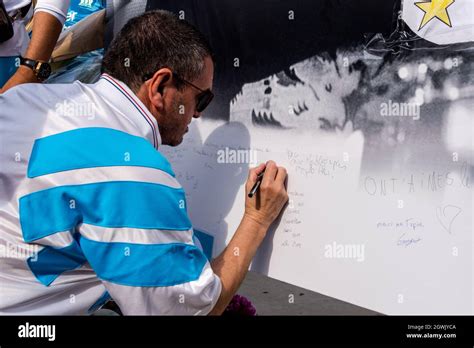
[0, 11, 288, 315]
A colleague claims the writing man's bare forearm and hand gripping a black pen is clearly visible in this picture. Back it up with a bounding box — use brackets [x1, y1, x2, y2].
[209, 161, 288, 315]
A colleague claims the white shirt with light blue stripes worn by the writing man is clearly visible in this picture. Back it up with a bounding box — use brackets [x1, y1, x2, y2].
[0, 74, 221, 315]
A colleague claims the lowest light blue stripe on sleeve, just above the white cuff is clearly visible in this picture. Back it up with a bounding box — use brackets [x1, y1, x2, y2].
[80, 236, 207, 287]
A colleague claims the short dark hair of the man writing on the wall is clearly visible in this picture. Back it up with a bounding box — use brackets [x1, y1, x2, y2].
[102, 10, 213, 92]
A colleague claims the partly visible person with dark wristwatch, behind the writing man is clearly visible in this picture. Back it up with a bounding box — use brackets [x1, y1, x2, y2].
[0, 0, 70, 93]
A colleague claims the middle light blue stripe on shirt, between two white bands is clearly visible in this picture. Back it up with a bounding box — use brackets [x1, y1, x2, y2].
[20, 181, 192, 242]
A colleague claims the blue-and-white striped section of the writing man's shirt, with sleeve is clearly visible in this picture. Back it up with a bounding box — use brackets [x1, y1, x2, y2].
[19, 128, 221, 315]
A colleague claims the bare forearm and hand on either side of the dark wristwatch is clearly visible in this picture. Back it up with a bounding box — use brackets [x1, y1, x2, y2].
[0, 2, 68, 93]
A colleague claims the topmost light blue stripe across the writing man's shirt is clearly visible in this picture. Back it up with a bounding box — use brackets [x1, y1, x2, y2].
[28, 127, 175, 178]
